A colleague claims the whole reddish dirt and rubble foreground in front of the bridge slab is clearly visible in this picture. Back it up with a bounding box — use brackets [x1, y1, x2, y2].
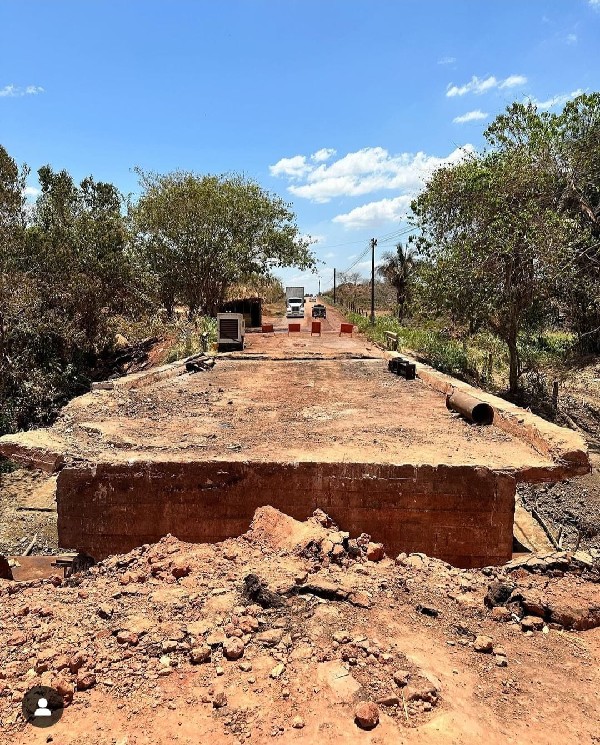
[0, 508, 600, 745]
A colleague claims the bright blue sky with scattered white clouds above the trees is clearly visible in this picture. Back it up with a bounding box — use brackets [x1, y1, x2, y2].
[0, 0, 600, 291]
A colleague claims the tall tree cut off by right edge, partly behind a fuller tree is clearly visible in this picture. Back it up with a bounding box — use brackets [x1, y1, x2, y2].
[486, 93, 600, 352]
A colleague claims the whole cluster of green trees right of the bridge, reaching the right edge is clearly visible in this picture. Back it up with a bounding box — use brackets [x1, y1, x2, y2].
[412, 94, 600, 394]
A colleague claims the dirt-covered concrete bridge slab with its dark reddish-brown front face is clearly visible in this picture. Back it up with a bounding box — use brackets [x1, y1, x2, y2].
[0, 304, 589, 567]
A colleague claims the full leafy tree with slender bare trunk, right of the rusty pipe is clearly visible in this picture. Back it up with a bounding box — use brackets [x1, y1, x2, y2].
[413, 149, 569, 394]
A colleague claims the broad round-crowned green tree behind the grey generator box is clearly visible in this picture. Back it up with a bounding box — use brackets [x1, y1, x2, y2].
[131, 169, 315, 315]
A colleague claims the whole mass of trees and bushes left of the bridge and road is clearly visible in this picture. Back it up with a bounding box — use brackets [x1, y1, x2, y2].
[0, 147, 314, 434]
